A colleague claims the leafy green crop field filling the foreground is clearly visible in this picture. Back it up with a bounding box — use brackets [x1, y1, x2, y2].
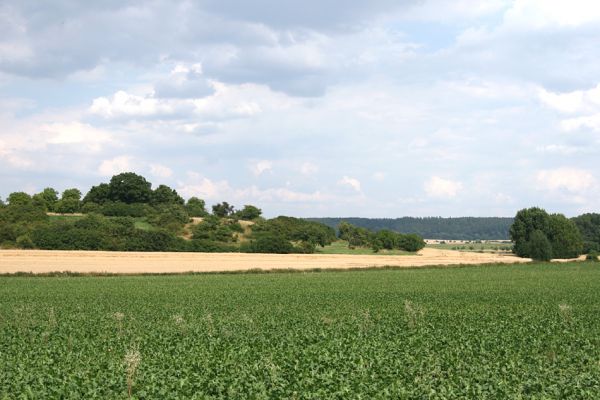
[0, 263, 600, 399]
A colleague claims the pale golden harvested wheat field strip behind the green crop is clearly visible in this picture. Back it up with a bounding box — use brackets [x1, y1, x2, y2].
[0, 248, 529, 274]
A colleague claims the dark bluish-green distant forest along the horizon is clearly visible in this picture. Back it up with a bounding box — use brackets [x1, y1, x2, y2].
[307, 217, 513, 240]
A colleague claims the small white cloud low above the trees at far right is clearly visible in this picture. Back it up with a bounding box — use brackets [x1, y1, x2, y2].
[536, 167, 596, 192]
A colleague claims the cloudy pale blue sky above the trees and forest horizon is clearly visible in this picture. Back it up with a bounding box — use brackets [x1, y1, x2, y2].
[0, 0, 600, 218]
